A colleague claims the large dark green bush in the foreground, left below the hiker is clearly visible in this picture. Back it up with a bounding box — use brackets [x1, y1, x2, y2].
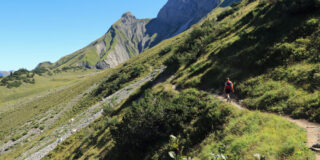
[108, 89, 231, 159]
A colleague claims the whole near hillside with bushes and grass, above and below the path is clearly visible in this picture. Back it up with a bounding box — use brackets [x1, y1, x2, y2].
[15, 0, 320, 160]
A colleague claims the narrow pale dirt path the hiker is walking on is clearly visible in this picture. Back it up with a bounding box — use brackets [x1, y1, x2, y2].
[213, 93, 320, 160]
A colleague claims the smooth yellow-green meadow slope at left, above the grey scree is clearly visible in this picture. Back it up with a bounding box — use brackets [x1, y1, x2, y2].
[0, 70, 107, 156]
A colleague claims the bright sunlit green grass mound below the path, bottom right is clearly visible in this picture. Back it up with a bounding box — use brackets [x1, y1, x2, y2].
[193, 111, 312, 160]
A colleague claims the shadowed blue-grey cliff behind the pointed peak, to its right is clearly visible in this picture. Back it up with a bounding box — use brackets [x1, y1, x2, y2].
[147, 0, 220, 45]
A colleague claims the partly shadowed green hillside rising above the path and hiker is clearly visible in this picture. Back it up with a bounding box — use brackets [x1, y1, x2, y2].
[167, 0, 320, 122]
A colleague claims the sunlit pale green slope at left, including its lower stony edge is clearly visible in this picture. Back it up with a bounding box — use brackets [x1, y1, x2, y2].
[0, 70, 104, 159]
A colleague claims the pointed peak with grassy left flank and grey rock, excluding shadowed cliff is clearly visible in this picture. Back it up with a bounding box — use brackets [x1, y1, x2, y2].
[54, 12, 150, 69]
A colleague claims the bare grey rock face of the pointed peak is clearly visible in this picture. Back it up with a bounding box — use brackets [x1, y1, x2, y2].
[96, 12, 151, 69]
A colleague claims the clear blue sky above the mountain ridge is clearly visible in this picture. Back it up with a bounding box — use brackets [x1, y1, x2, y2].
[0, 0, 167, 71]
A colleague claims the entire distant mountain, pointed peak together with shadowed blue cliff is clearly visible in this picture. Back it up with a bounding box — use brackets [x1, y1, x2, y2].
[39, 0, 225, 69]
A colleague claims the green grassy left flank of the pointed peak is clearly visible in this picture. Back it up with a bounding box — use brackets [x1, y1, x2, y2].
[52, 19, 153, 69]
